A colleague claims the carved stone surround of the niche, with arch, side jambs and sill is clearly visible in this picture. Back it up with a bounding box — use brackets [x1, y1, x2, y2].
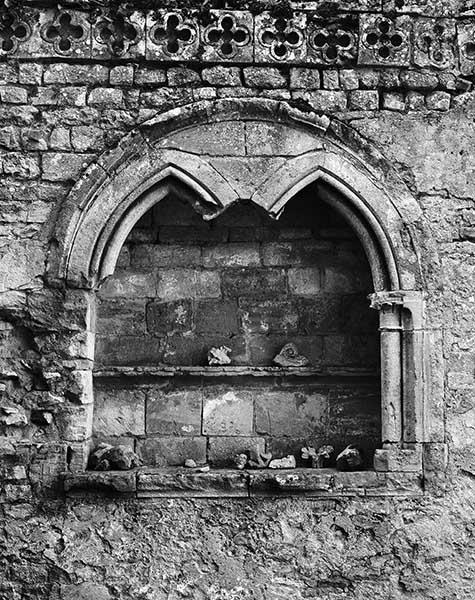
[48, 99, 447, 496]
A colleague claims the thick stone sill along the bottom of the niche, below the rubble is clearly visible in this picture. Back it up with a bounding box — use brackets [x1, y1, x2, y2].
[63, 467, 423, 499]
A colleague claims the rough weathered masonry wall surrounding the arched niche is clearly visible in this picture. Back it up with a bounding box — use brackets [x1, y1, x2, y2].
[0, 0, 475, 600]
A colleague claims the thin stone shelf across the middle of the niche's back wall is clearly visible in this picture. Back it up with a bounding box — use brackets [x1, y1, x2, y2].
[93, 365, 379, 377]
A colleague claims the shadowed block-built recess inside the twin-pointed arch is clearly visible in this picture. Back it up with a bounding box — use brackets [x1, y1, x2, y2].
[93, 185, 381, 468]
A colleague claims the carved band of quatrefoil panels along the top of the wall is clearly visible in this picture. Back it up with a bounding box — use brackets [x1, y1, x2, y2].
[0, 7, 475, 75]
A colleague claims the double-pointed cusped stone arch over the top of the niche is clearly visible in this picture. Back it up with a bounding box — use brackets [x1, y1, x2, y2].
[48, 99, 428, 291]
